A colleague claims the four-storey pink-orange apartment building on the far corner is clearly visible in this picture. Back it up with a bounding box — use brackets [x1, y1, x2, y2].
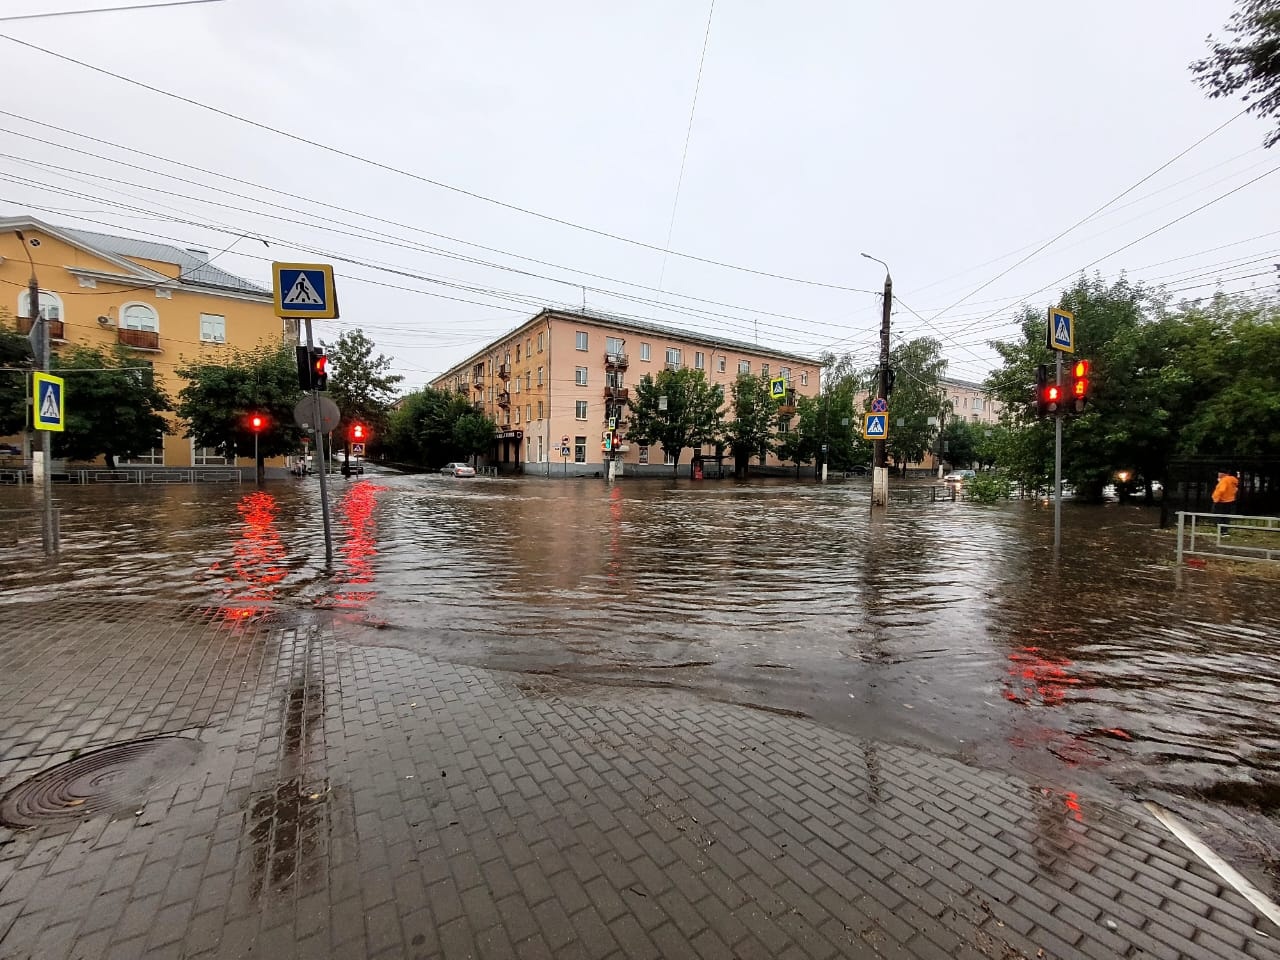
[431, 310, 820, 475]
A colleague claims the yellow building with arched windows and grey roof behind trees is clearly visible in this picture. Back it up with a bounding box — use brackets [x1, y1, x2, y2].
[0, 216, 297, 467]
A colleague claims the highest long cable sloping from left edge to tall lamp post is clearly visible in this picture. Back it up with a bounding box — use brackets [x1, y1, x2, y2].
[0, 33, 873, 293]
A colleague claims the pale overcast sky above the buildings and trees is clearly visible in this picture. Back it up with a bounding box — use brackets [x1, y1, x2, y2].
[0, 0, 1280, 385]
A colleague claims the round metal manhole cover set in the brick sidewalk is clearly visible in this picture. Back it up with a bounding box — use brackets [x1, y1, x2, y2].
[0, 737, 202, 827]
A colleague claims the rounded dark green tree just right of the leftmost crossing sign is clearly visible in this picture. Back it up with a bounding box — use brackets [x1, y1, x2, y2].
[50, 347, 173, 470]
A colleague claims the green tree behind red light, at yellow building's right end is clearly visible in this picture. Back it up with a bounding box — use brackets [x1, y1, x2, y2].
[177, 343, 302, 483]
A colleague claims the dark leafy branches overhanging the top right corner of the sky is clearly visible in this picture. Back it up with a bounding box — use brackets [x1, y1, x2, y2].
[1190, 0, 1280, 147]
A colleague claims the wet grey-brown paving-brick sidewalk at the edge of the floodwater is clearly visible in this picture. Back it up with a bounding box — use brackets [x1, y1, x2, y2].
[0, 599, 1280, 960]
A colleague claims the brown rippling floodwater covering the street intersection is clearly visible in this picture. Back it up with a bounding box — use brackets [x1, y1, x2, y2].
[0, 472, 1280, 885]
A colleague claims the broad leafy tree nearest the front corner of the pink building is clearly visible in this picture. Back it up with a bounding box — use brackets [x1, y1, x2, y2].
[627, 367, 724, 475]
